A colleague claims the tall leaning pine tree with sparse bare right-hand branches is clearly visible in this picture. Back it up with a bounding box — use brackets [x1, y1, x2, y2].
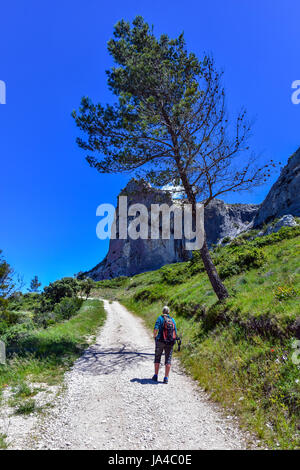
[73, 17, 268, 300]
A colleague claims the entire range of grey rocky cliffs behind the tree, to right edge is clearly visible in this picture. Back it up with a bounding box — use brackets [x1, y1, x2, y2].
[84, 149, 300, 280]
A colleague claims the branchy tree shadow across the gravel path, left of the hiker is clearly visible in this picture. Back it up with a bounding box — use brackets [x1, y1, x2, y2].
[75, 344, 154, 375]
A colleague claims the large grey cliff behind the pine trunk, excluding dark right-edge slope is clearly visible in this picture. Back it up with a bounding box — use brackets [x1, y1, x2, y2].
[85, 179, 259, 280]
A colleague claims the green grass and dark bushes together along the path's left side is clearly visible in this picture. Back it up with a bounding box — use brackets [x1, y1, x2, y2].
[0, 272, 105, 448]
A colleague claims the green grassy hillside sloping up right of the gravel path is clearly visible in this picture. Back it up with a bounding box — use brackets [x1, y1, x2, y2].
[92, 226, 300, 449]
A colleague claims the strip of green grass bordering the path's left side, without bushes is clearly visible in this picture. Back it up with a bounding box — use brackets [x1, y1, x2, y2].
[0, 300, 105, 448]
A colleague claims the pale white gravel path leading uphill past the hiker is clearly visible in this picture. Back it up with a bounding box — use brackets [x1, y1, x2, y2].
[19, 301, 246, 450]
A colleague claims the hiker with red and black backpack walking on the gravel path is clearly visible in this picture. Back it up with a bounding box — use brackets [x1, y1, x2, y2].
[152, 306, 177, 384]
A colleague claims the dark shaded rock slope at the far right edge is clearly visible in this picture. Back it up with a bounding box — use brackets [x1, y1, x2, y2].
[254, 148, 300, 227]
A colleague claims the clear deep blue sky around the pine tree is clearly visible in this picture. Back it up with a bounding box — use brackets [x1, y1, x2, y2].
[0, 0, 300, 285]
